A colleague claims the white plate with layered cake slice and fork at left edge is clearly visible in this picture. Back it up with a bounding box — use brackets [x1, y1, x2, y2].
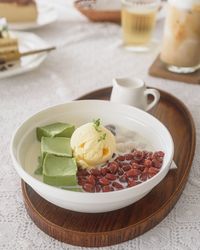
[0, 32, 49, 79]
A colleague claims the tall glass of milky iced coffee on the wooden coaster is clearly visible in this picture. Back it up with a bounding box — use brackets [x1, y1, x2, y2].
[160, 0, 200, 73]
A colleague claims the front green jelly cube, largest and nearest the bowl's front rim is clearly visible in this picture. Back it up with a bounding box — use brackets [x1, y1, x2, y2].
[43, 154, 77, 186]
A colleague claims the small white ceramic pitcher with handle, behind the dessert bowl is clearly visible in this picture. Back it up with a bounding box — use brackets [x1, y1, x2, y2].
[110, 78, 160, 111]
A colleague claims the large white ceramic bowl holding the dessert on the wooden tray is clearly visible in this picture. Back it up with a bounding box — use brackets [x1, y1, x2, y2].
[11, 100, 174, 213]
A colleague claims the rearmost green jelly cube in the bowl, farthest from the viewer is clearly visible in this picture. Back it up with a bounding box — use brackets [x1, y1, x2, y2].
[37, 122, 75, 141]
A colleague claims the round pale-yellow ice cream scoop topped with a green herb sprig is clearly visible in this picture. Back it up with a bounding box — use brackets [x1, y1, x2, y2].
[70, 123, 116, 168]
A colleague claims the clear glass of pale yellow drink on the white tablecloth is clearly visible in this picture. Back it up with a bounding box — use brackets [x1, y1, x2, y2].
[121, 0, 160, 51]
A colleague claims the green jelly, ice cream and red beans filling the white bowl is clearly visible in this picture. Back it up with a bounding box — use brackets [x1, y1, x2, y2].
[33, 119, 165, 193]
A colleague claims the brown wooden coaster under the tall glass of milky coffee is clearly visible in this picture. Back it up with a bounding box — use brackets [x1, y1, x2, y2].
[149, 55, 200, 84]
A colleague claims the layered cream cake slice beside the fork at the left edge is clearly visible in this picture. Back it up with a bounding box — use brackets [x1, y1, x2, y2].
[0, 18, 19, 63]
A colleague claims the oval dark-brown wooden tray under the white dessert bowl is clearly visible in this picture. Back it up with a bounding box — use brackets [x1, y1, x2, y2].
[22, 88, 195, 247]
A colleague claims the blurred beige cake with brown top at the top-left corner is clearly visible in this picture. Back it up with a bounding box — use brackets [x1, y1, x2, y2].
[0, 0, 38, 23]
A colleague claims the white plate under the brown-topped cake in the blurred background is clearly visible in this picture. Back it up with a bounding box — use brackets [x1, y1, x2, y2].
[9, 2, 58, 30]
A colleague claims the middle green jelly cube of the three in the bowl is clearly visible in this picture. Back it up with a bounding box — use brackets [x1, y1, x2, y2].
[41, 137, 72, 157]
